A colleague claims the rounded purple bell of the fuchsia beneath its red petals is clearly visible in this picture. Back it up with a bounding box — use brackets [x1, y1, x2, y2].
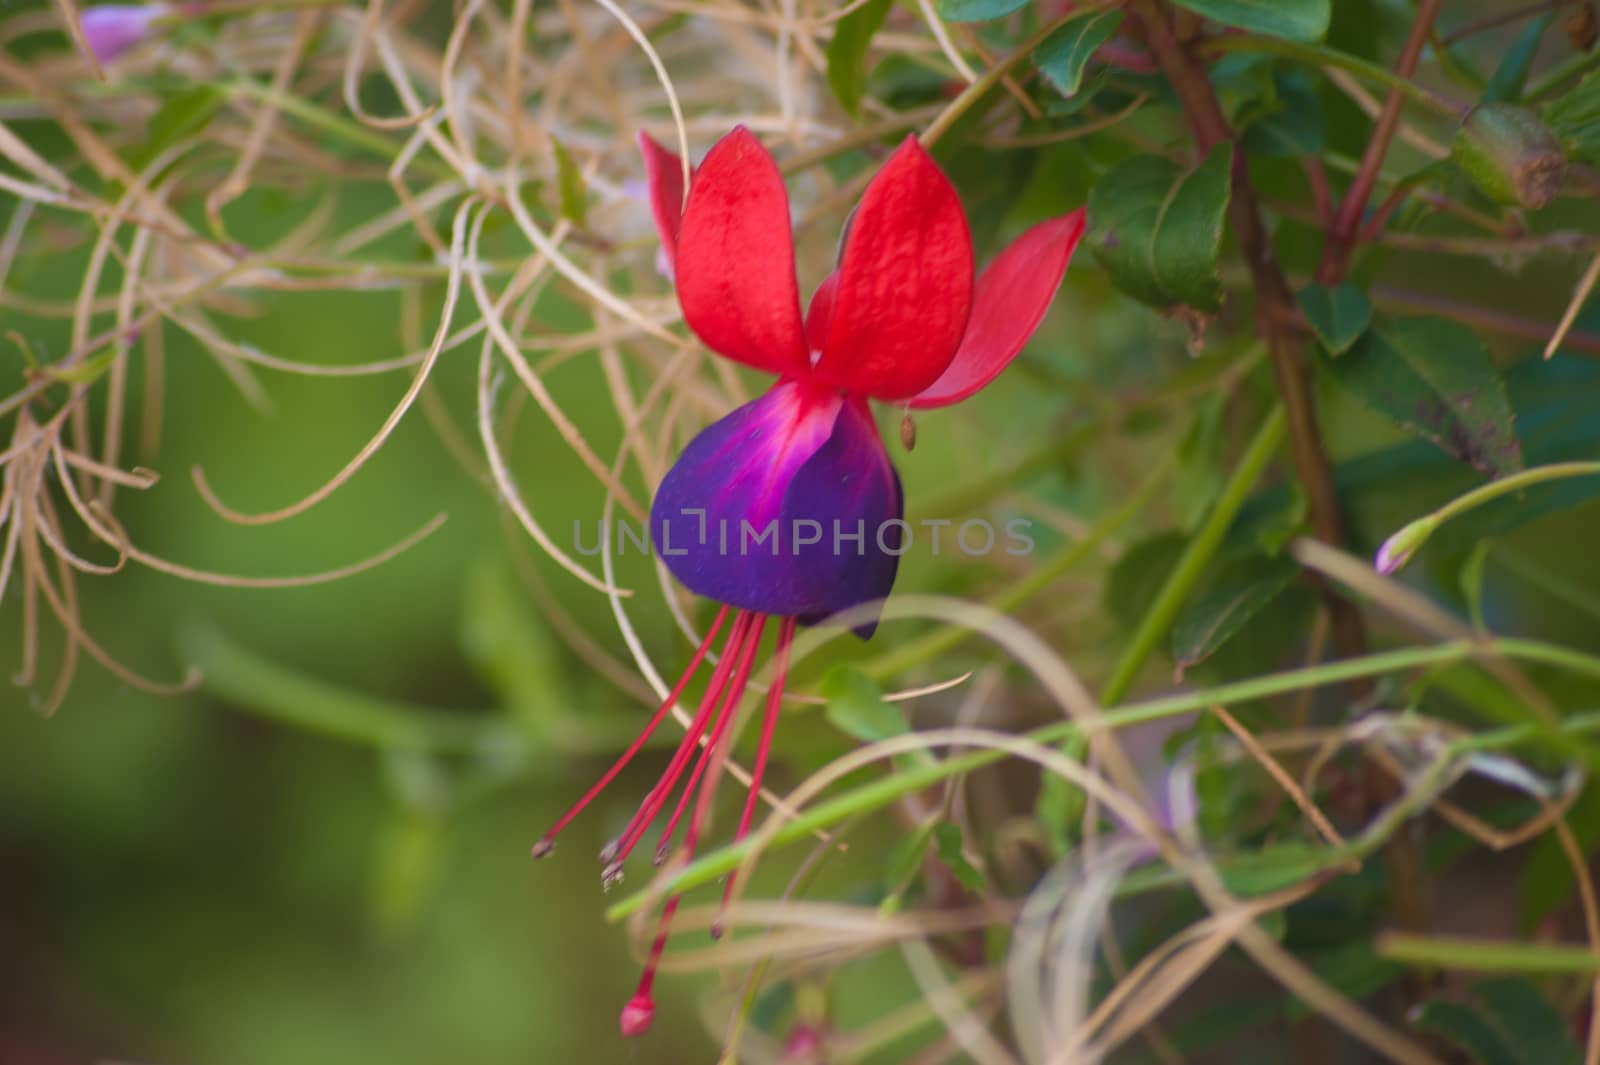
[650, 381, 904, 638]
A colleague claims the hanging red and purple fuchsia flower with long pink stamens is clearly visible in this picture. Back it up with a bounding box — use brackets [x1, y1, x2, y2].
[533, 126, 1083, 1035]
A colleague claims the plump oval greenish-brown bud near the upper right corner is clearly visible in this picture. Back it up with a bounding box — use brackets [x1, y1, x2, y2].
[1451, 104, 1566, 208]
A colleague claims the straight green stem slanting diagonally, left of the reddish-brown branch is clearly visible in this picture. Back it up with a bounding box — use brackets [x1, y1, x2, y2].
[1101, 406, 1286, 707]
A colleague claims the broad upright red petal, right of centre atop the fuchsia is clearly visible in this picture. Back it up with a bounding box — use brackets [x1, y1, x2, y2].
[814, 138, 973, 400]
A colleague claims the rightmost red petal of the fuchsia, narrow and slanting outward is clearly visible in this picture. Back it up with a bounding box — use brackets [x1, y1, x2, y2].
[910, 208, 1083, 408]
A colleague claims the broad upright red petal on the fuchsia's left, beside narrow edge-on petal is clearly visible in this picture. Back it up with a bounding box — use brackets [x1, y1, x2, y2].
[677, 126, 811, 376]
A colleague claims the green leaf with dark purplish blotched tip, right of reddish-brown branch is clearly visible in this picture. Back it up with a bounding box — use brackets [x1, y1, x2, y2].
[1322, 318, 1522, 477]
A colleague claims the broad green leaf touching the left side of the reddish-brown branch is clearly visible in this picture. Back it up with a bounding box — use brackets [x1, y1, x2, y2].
[1088, 144, 1234, 313]
